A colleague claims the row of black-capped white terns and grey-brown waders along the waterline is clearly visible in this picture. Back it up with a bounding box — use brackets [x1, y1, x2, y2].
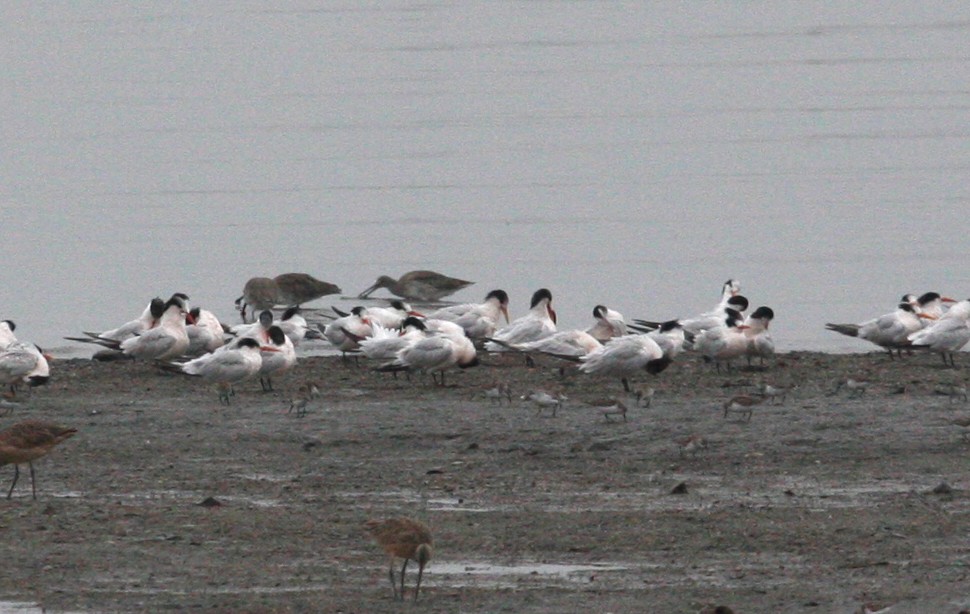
[0, 271, 970, 410]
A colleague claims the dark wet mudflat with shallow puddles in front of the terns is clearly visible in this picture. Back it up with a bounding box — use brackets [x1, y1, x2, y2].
[0, 353, 970, 614]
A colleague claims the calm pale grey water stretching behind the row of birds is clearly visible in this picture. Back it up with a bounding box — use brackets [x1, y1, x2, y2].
[0, 0, 970, 353]
